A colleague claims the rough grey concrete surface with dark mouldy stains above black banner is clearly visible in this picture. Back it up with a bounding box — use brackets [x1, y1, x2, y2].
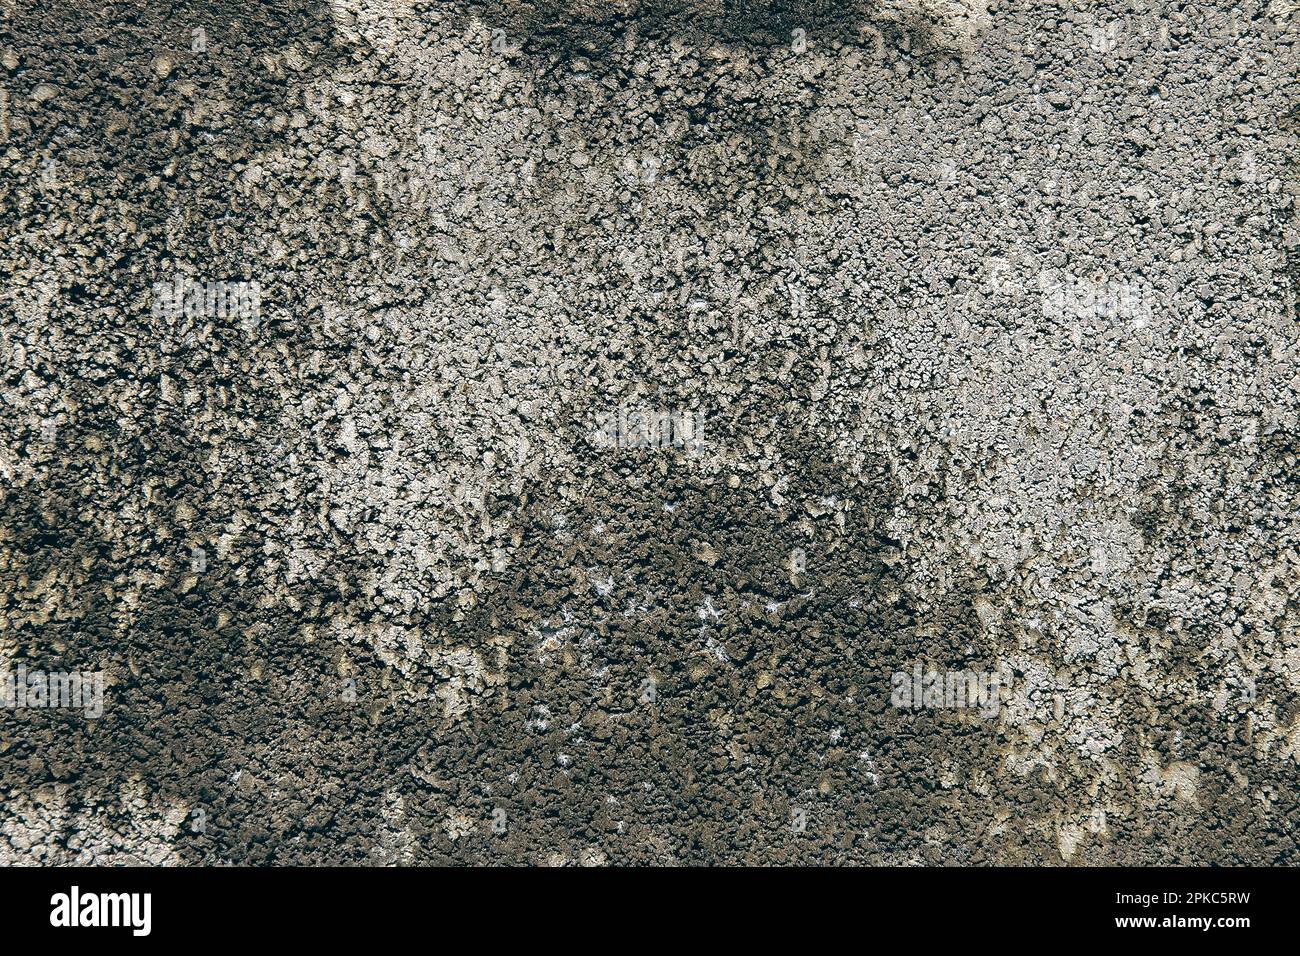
[0, 0, 1300, 865]
